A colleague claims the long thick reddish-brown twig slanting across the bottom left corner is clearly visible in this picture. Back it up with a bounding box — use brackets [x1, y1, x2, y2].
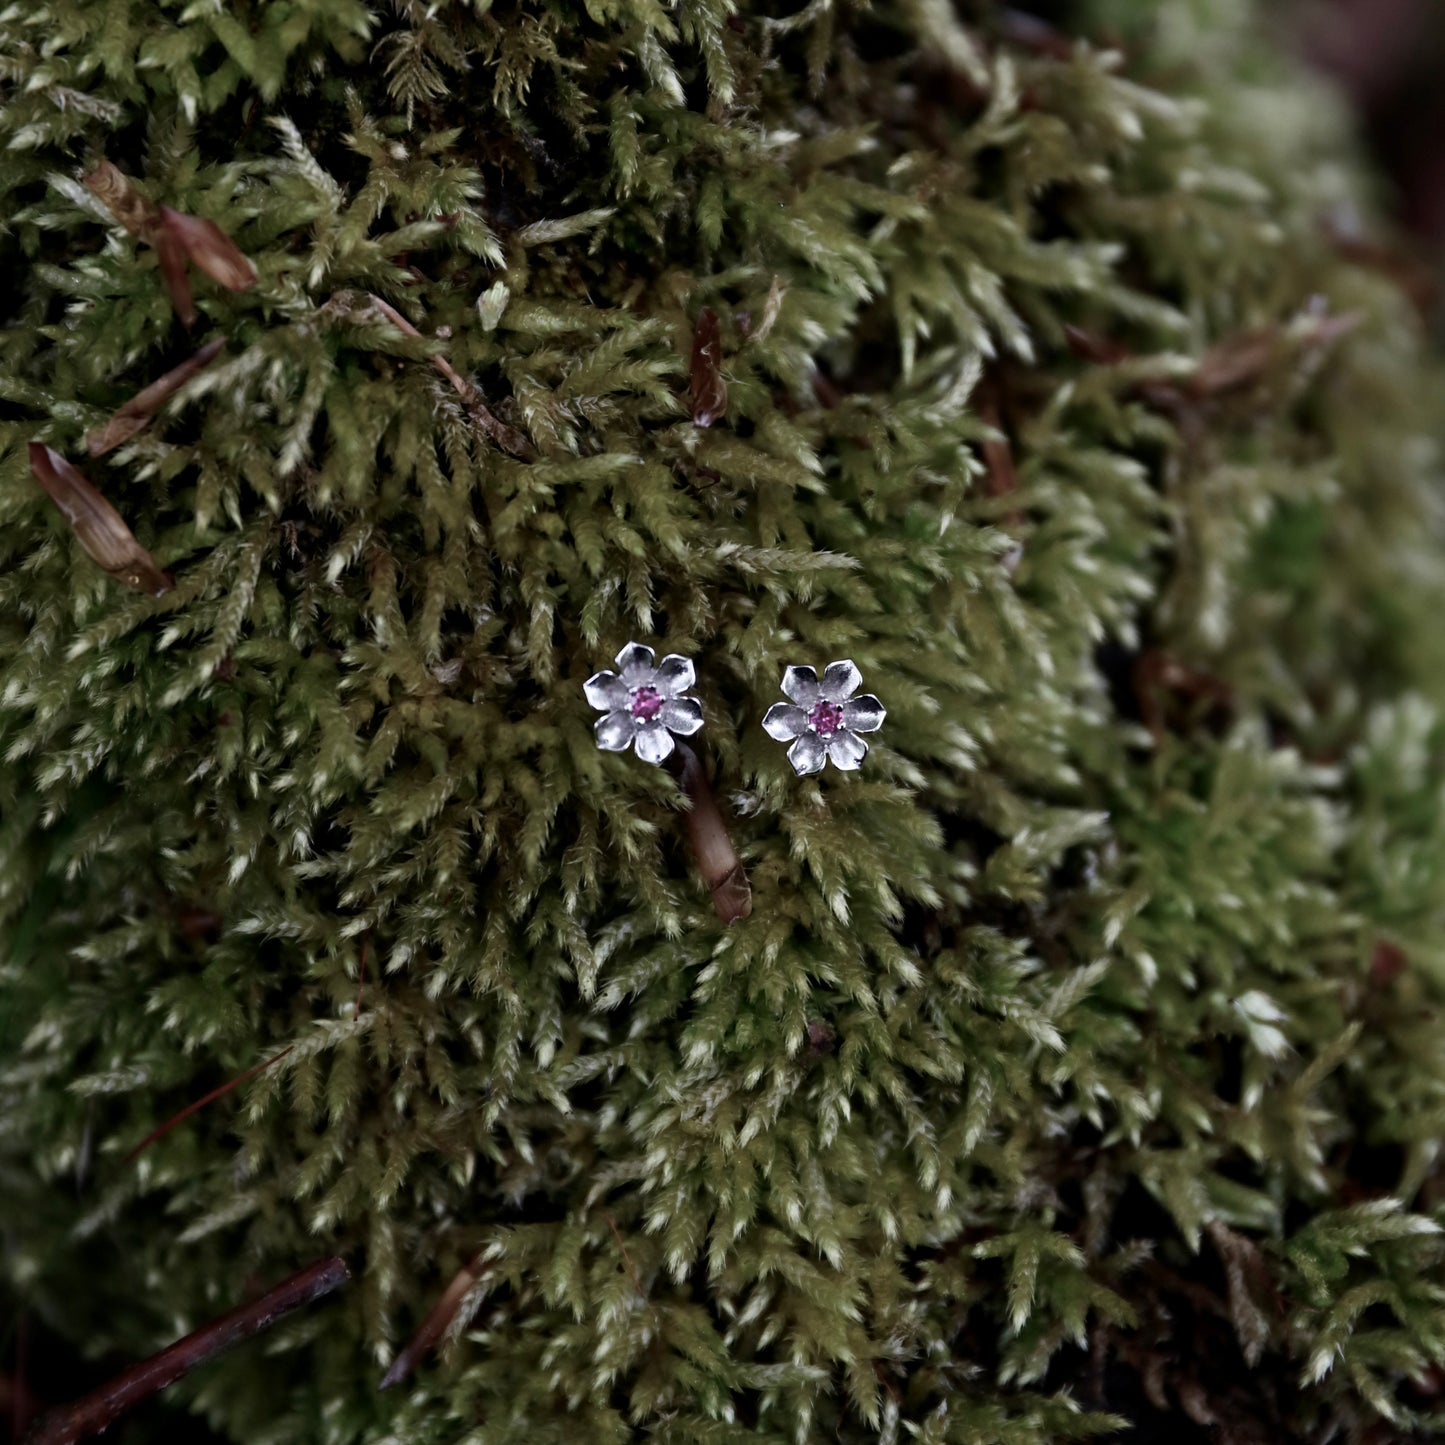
[25, 1256, 351, 1445]
